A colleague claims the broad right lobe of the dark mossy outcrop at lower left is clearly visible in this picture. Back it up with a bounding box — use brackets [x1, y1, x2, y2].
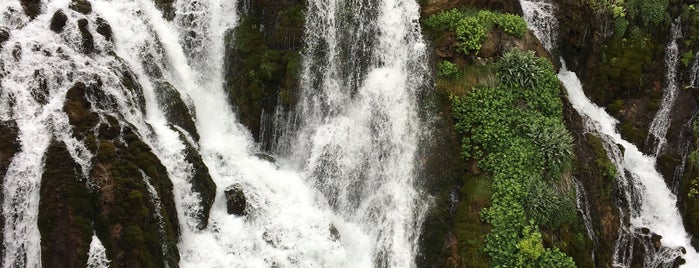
[91, 131, 179, 267]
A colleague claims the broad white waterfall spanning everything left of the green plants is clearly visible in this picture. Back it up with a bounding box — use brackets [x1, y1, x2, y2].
[0, 0, 427, 267]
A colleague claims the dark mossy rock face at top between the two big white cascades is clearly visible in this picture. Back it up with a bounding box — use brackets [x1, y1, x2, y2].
[225, 0, 305, 144]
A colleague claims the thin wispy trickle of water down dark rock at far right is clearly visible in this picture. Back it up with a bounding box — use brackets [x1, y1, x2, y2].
[646, 21, 682, 157]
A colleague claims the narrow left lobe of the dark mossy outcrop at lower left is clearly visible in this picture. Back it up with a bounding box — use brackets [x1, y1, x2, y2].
[38, 140, 95, 267]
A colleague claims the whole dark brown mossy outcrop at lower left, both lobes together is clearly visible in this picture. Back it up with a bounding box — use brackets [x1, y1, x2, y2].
[39, 83, 179, 267]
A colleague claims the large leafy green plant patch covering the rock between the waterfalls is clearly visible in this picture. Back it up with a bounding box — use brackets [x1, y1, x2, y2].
[452, 50, 576, 267]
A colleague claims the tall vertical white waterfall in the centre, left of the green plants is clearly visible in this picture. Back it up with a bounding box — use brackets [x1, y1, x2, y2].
[278, 0, 428, 267]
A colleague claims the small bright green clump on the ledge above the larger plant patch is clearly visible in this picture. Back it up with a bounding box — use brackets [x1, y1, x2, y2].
[424, 9, 527, 55]
